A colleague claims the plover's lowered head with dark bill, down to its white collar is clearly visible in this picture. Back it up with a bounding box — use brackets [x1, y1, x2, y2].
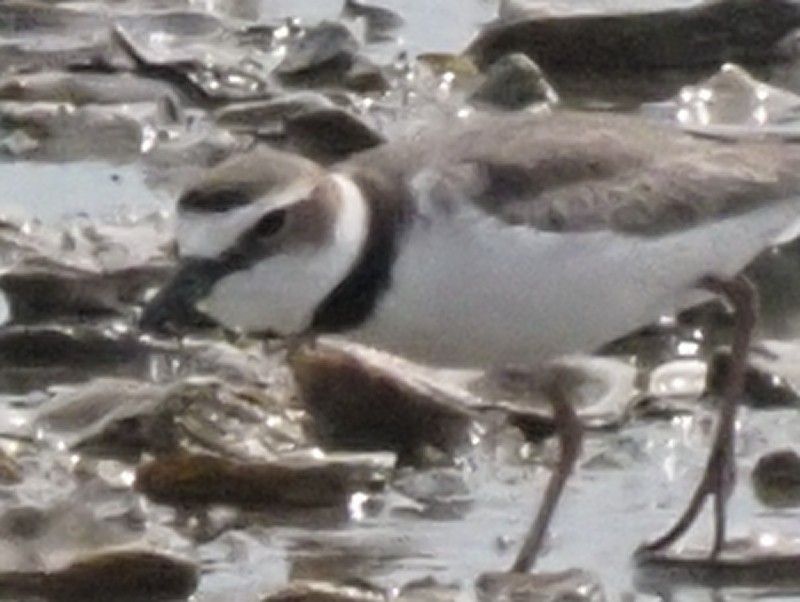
[141, 147, 368, 336]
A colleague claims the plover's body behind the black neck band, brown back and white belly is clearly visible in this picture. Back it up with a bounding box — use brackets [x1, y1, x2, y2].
[347, 113, 800, 365]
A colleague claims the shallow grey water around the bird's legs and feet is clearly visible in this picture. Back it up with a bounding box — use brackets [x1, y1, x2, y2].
[180, 412, 800, 600]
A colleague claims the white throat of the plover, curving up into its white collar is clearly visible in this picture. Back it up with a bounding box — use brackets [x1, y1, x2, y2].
[201, 174, 369, 335]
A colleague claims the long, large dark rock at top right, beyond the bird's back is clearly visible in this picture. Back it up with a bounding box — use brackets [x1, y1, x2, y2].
[467, 0, 800, 100]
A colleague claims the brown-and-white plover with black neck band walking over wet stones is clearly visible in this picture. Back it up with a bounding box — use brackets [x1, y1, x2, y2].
[142, 106, 800, 571]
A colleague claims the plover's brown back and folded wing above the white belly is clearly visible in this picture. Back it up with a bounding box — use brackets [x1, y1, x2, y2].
[376, 112, 800, 236]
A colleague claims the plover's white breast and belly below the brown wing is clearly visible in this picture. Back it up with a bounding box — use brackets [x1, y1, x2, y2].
[352, 200, 800, 366]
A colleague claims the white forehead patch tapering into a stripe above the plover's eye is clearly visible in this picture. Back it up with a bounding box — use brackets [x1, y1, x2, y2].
[175, 181, 315, 258]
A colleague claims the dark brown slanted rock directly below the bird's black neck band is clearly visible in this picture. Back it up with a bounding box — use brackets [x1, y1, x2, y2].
[290, 341, 473, 462]
